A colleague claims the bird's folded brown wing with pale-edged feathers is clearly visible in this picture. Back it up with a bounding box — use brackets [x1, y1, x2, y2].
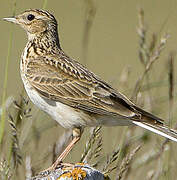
[25, 55, 144, 120]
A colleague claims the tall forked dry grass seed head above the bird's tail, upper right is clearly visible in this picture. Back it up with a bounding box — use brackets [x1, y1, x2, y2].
[131, 9, 169, 102]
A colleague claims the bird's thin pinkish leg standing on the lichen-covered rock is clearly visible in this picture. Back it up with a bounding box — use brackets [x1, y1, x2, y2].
[42, 128, 82, 171]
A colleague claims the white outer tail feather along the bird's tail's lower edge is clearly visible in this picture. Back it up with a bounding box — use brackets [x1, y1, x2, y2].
[133, 121, 177, 142]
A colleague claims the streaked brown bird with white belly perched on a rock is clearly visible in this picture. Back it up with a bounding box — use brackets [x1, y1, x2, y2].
[3, 9, 177, 172]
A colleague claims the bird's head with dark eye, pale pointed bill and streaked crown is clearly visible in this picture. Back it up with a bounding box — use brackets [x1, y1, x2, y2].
[3, 9, 57, 35]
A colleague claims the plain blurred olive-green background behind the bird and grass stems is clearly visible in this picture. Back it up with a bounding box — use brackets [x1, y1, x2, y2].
[0, 0, 177, 179]
